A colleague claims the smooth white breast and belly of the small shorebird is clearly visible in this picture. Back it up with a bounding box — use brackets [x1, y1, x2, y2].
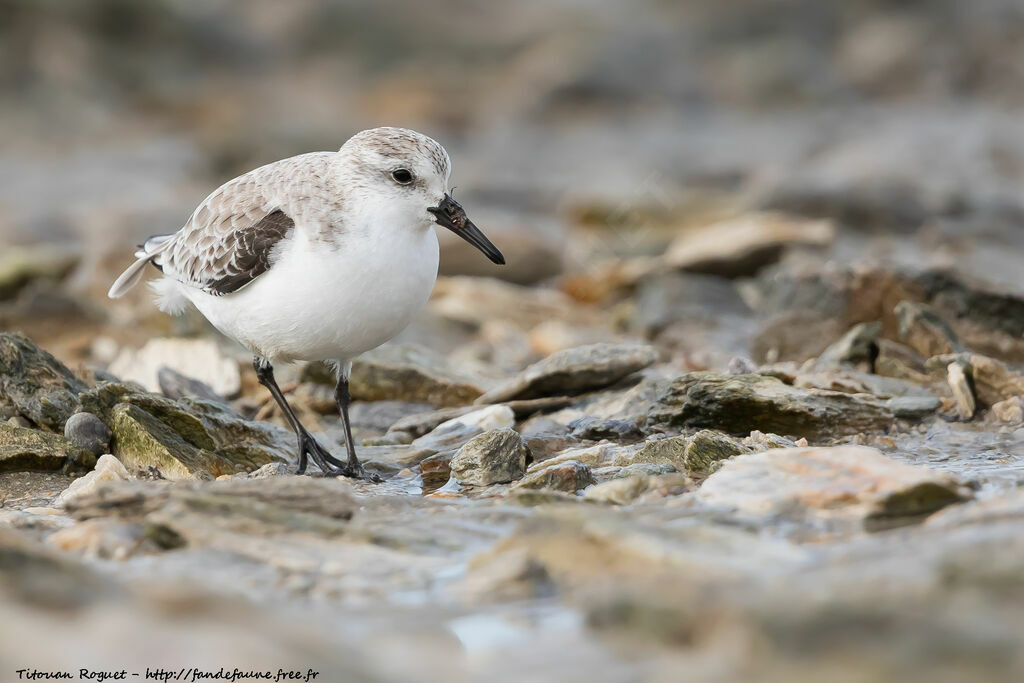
[187, 228, 438, 361]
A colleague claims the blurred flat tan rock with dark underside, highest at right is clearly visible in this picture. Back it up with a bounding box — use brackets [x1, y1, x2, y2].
[665, 213, 836, 278]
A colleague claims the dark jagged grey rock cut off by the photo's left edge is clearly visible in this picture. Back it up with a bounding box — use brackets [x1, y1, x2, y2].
[0, 332, 88, 431]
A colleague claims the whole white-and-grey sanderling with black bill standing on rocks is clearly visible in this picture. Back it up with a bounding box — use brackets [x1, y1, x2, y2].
[109, 128, 505, 477]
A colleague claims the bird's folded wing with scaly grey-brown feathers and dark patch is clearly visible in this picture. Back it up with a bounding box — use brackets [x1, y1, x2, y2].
[155, 176, 295, 296]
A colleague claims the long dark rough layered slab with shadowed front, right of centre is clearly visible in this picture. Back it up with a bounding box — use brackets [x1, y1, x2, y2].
[647, 373, 896, 437]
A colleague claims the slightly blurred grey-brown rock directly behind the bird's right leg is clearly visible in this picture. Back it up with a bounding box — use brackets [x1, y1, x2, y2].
[349, 344, 484, 407]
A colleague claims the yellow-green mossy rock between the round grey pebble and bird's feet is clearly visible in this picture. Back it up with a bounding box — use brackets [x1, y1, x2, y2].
[81, 383, 295, 479]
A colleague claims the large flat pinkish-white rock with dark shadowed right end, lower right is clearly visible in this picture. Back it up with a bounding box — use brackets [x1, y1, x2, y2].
[695, 445, 970, 527]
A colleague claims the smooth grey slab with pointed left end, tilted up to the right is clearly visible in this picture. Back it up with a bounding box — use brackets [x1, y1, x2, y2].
[476, 343, 657, 403]
